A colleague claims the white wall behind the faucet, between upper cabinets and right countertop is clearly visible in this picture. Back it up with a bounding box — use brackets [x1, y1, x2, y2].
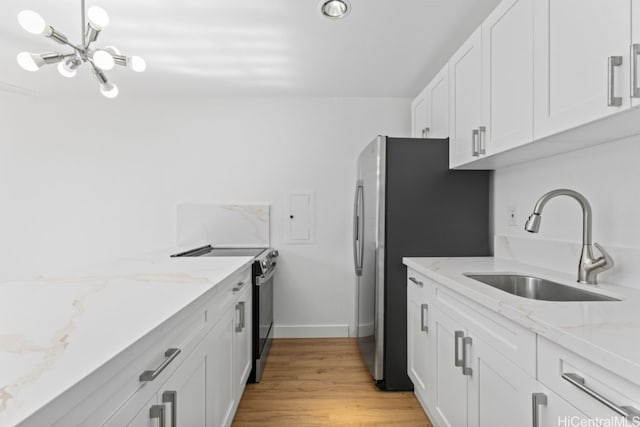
[493, 137, 640, 288]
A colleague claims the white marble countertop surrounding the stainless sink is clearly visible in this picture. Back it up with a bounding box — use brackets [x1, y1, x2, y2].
[403, 257, 640, 385]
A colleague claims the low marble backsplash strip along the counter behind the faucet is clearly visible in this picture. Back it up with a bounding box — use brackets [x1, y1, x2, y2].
[494, 235, 640, 289]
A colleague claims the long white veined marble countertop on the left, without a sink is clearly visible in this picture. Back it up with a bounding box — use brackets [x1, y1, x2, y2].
[0, 250, 253, 426]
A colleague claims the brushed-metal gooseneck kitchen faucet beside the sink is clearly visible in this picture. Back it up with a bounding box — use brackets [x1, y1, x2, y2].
[524, 188, 613, 285]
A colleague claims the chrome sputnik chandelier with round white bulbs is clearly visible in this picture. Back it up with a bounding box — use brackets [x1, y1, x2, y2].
[17, 0, 147, 98]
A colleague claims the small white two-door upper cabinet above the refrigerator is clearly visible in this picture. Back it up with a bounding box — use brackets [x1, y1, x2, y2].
[411, 65, 449, 138]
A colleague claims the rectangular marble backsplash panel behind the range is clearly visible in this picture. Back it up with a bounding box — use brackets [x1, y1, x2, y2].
[176, 204, 270, 248]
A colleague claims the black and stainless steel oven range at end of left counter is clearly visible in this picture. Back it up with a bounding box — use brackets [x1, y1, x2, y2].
[171, 245, 278, 383]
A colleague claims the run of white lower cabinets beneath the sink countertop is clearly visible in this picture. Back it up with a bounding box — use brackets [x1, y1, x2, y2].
[407, 269, 612, 427]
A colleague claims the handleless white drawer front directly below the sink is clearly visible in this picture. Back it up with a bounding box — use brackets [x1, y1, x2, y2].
[435, 287, 536, 377]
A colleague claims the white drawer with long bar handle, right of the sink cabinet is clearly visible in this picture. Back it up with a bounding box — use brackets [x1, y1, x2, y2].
[538, 337, 640, 425]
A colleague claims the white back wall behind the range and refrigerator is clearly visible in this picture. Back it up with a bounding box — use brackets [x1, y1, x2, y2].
[0, 90, 410, 335]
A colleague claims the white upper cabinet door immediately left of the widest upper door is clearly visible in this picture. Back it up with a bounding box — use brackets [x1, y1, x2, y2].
[479, 0, 534, 154]
